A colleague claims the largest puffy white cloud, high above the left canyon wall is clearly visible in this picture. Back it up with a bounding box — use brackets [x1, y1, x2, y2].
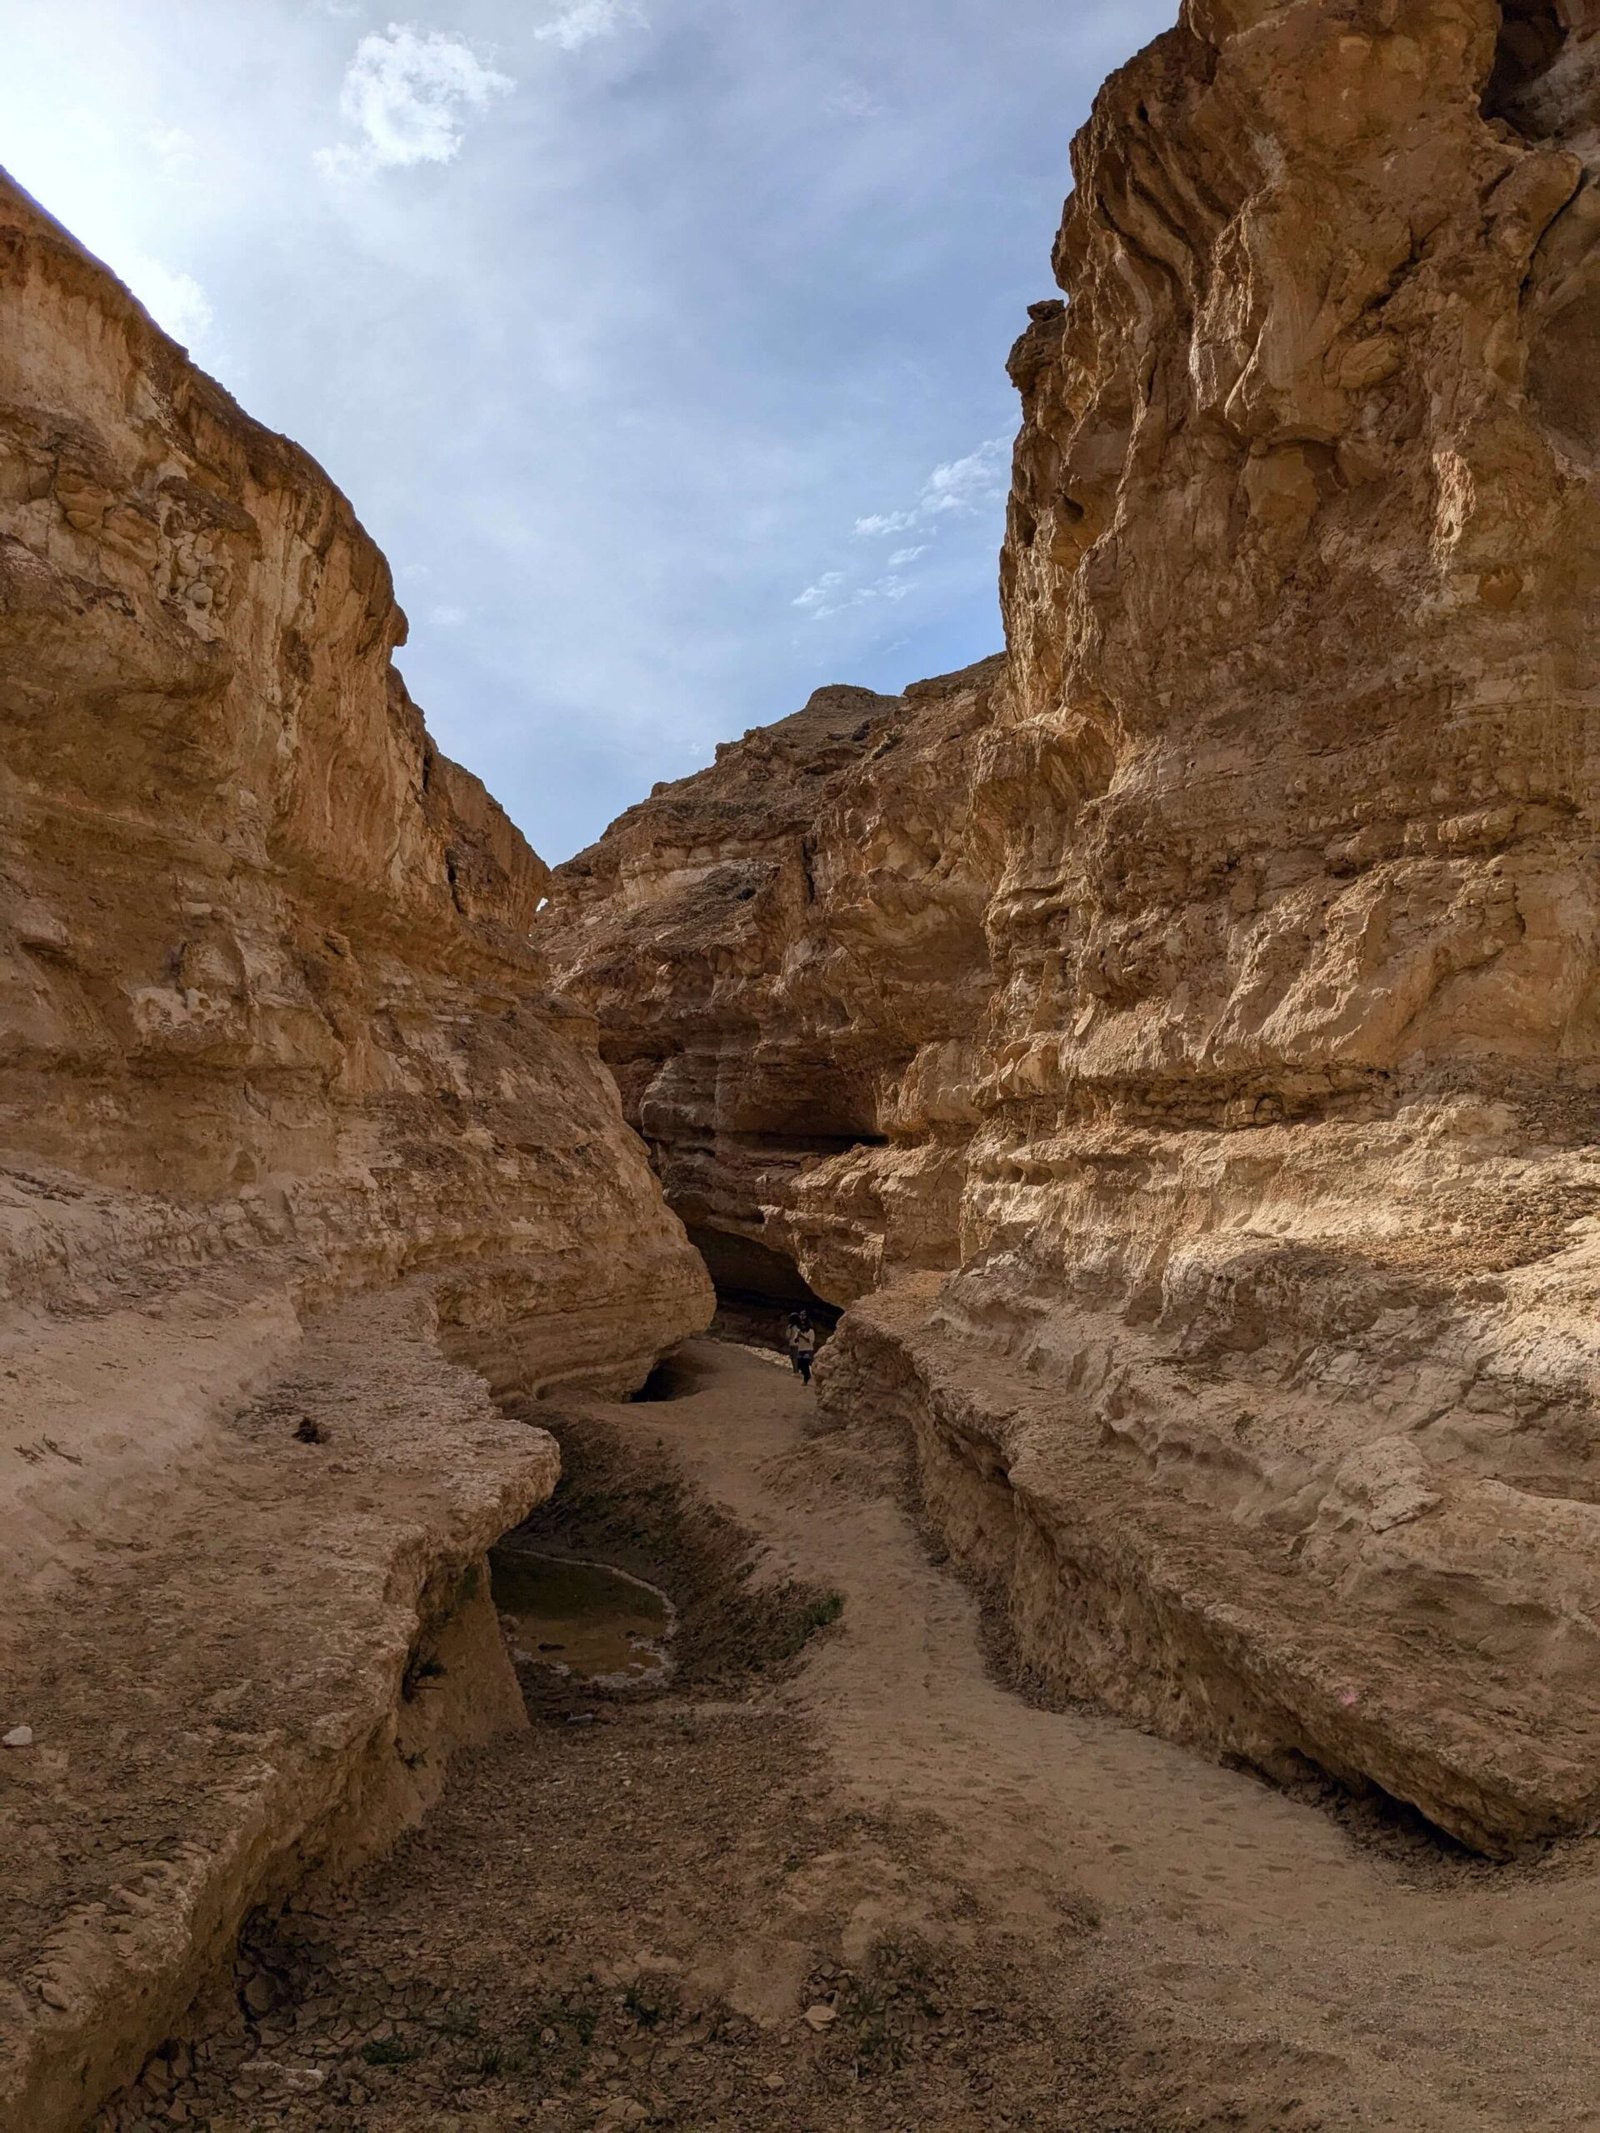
[316, 21, 516, 177]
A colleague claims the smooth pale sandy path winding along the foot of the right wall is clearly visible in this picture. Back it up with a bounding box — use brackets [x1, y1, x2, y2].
[670, 1361, 1600, 2133]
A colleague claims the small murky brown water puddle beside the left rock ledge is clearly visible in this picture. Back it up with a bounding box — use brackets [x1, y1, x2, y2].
[489, 1546, 676, 1689]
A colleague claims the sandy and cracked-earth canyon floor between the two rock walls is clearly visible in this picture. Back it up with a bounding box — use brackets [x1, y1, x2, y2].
[107, 1340, 1600, 2133]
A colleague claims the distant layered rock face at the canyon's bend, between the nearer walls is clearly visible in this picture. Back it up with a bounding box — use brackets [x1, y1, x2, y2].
[540, 661, 998, 1303]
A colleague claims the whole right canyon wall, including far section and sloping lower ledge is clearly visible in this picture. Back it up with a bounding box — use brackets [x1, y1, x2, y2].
[550, 0, 1600, 1851]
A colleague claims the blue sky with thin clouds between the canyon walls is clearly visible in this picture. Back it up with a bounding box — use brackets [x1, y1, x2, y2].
[0, 0, 1175, 860]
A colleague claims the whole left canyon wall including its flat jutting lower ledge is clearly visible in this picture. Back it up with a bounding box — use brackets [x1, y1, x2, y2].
[0, 179, 710, 2133]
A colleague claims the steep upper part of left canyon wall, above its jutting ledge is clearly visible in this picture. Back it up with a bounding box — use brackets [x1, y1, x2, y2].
[0, 170, 702, 1382]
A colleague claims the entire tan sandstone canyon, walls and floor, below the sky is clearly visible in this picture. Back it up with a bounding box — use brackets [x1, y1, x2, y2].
[0, 0, 1600, 2133]
